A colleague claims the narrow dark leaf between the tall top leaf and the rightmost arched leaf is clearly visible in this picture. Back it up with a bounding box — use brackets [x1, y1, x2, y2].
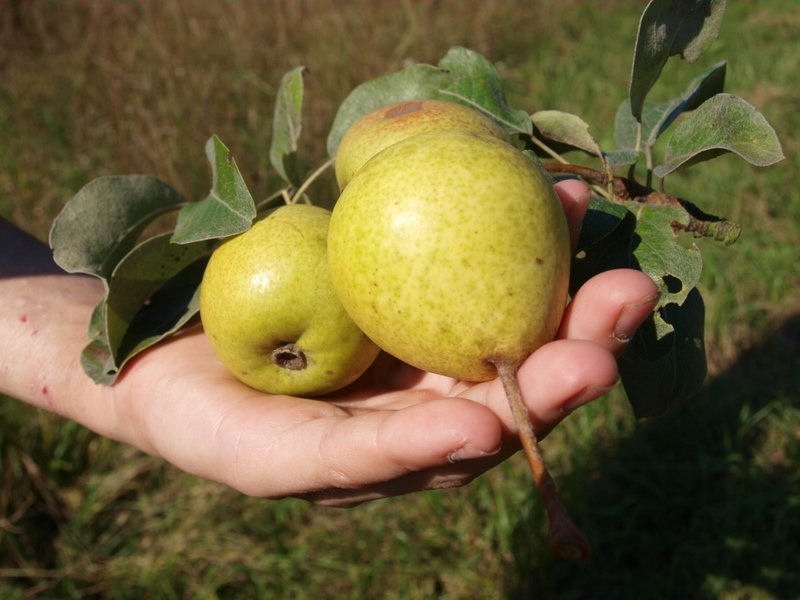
[614, 61, 726, 148]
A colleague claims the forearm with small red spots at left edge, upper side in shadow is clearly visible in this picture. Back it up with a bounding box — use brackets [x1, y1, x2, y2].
[0, 219, 108, 418]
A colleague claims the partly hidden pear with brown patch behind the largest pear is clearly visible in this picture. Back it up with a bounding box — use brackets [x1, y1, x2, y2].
[334, 99, 508, 189]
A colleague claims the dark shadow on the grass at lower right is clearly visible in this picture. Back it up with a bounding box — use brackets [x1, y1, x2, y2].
[509, 314, 800, 599]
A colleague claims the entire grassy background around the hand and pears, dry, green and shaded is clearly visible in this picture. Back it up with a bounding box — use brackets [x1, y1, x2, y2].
[0, 2, 800, 599]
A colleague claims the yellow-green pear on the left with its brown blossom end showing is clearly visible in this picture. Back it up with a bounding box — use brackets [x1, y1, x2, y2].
[200, 204, 379, 396]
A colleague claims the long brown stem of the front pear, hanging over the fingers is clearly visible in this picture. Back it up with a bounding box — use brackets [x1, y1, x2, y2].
[492, 359, 591, 560]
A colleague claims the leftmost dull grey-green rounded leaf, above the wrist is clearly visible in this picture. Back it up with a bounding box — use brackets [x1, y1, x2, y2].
[50, 175, 184, 279]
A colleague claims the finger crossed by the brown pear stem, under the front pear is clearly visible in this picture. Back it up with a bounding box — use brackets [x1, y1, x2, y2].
[461, 340, 618, 435]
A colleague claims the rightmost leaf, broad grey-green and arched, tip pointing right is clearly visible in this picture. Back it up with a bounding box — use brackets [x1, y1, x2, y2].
[653, 94, 784, 177]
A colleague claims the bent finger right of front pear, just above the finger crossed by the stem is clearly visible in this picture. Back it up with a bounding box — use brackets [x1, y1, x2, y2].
[558, 269, 659, 354]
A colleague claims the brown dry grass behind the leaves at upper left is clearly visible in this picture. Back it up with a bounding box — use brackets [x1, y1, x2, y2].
[0, 2, 572, 236]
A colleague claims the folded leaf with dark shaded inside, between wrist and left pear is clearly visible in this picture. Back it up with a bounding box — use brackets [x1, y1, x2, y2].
[82, 233, 212, 384]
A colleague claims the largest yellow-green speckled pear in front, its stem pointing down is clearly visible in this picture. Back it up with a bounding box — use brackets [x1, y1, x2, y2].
[328, 131, 570, 381]
